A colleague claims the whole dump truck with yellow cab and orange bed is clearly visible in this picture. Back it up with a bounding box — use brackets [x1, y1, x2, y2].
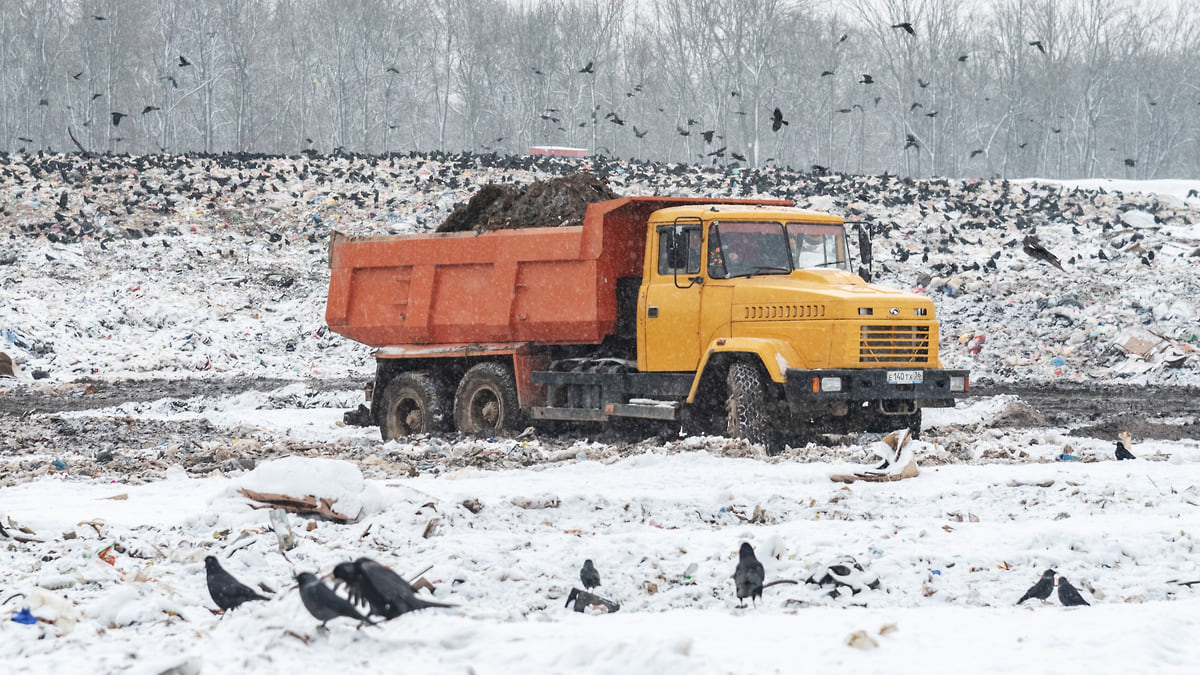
[326, 197, 968, 452]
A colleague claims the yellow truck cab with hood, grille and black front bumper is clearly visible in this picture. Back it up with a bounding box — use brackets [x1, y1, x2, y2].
[637, 204, 967, 446]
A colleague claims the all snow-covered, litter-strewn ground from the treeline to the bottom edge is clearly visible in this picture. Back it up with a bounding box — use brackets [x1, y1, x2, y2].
[0, 157, 1200, 674]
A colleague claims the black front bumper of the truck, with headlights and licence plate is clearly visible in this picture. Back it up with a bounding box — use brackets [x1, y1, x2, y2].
[784, 368, 971, 407]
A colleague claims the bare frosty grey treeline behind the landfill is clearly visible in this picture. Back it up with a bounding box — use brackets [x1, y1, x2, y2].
[0, 0, 1200, 178]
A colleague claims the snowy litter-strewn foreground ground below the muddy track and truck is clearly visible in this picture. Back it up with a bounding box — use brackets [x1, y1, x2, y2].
[0, 399, 1200, 673]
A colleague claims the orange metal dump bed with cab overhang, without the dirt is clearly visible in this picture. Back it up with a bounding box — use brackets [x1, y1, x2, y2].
[325, 197, 792, 347]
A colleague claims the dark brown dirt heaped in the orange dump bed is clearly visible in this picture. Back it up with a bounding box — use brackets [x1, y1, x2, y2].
[437, 172, 620, 232]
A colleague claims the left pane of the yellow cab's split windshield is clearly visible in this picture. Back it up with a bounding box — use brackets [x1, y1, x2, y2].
[708, 221, 792, 279]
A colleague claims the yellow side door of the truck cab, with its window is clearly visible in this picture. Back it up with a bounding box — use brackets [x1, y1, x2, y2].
[637, 223, 702, 371]
